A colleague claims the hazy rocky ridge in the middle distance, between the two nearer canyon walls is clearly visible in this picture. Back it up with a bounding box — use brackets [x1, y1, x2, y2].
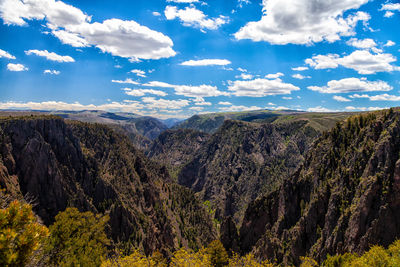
[178, 120, 319, 223]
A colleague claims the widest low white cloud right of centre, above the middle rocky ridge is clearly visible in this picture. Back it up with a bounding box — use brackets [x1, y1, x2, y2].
[228, 79, 300, 97]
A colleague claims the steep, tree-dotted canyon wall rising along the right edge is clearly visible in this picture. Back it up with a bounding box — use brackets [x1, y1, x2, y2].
[240, 110, 400, 265]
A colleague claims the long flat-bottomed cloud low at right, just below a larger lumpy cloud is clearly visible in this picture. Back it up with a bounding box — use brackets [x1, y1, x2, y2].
[308, 78, 393, 94]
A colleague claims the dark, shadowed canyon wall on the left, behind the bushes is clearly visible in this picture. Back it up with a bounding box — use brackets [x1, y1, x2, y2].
[0, 116, 215, 254]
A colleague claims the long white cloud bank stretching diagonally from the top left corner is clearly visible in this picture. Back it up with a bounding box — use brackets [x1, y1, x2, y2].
[0, 0, 176, 61]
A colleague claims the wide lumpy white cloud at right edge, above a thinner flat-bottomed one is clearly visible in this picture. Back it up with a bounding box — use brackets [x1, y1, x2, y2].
[305, 50, 400, 74]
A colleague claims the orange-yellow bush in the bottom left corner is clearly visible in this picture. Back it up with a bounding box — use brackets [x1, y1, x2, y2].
[0, 201, 48, 266]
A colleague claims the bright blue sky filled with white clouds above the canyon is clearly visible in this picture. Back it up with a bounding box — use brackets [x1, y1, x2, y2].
[0, 0, 400, 118]
